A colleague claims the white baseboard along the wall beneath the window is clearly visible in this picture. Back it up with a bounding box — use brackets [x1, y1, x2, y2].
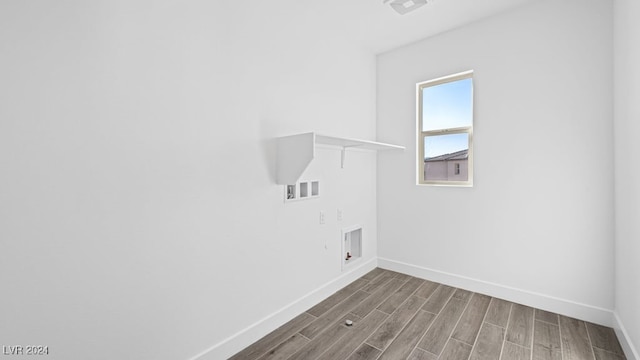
[378, 258, 616, 326]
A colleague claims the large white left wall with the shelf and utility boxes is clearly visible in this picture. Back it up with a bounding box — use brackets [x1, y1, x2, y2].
[0, 0, 377, 360]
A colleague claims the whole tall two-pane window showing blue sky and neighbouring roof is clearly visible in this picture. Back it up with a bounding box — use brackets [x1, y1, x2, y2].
[417, 71, 473, 186]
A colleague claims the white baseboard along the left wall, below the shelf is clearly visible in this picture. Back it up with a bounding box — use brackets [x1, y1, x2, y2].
[190, 258, 378, 360]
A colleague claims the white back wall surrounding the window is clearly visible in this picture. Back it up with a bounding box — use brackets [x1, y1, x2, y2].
[377, 0, 612, 324]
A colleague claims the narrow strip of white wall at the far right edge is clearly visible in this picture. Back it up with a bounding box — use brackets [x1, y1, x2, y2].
[614, 0, 640, 359]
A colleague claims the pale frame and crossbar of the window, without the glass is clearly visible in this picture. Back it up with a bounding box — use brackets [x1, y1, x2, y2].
[416, 70, 474, 187]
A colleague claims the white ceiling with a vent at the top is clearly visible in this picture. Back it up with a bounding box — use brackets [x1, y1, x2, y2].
[307, 0, 533, 53]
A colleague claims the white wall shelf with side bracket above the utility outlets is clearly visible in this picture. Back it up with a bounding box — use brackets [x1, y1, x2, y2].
[276, 132, 404, 185]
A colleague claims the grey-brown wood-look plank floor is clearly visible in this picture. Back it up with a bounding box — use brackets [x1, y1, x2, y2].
[231, 268, 625, 360]
